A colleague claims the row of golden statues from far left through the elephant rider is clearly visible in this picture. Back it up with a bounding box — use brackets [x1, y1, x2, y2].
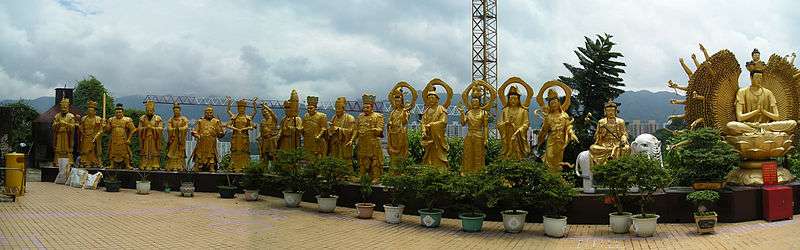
[53, 77, 629, 182]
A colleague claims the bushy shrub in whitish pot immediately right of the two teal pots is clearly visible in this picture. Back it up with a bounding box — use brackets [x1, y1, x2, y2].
[486, 161, 544, 233]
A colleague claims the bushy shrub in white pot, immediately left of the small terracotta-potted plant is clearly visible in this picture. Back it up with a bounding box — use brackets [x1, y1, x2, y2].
[308, 157, 352, 213]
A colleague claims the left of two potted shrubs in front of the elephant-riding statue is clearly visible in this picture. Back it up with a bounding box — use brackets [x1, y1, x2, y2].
[593, 156, 642, 234]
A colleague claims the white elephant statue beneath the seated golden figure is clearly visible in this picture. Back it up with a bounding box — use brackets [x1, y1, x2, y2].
[575, 134, 664, 194]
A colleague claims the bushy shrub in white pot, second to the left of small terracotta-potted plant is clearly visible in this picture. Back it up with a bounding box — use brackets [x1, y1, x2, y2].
[273, 149, 309, 207]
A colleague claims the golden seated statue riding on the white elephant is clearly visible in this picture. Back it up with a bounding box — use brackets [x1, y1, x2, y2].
[587, 100, 631, 166]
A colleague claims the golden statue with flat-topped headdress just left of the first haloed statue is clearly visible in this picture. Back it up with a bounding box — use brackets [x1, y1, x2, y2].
[346, 94, 383, 183]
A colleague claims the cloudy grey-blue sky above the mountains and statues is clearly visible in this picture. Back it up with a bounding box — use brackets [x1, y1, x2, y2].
[0, 0, 800, 100]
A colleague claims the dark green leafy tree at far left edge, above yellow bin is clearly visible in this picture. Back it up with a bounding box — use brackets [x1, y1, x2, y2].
[3, 100, 39, 153]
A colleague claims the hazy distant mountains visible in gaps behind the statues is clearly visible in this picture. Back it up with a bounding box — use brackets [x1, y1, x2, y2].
[0, 90, 683, 126]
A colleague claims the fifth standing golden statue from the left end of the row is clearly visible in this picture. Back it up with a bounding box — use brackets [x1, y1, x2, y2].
[165, 103, 189, 171]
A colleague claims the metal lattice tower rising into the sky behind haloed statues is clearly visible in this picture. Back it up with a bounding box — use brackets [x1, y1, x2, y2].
[472, 0, 498, 88]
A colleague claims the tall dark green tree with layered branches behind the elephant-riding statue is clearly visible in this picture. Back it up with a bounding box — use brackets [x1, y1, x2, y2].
[559, 34, 625, 162]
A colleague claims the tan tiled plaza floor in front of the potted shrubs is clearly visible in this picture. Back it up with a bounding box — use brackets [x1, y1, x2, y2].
[0, 182, 800, 250]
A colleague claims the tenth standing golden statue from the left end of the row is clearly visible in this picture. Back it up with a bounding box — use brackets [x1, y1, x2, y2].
[303, 96, 328, 157]
